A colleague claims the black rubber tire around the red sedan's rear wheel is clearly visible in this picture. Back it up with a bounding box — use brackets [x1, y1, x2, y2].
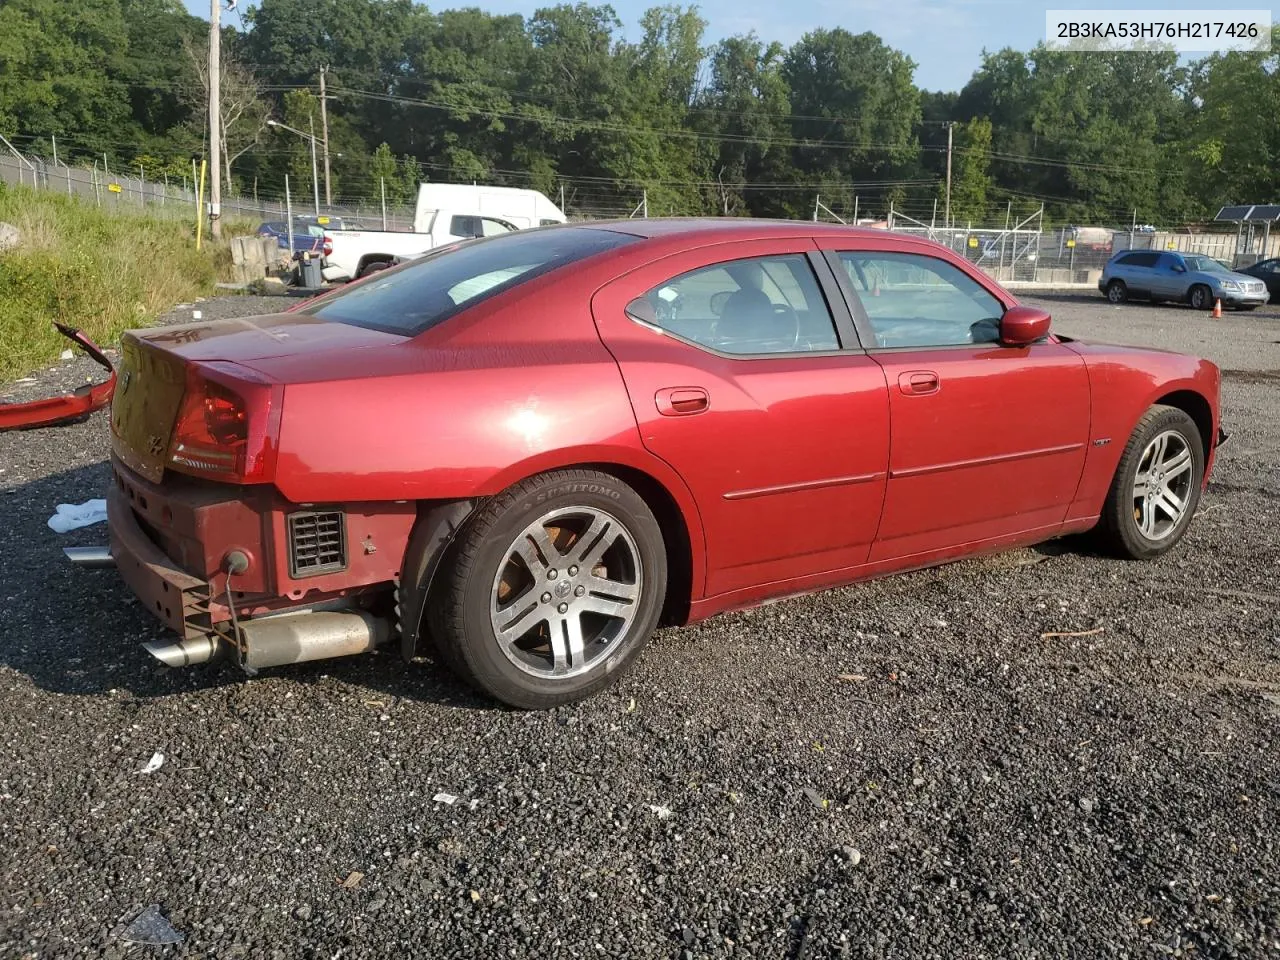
[428, 470, 667, 710]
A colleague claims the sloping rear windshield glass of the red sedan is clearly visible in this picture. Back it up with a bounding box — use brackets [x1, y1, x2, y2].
[302, 227, 636, 337]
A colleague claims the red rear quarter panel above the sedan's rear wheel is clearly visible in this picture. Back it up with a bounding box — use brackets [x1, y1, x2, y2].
[253, 261, 703, 593]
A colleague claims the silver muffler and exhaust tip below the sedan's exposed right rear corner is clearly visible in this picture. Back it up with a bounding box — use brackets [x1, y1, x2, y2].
[142, 611, 390, 672]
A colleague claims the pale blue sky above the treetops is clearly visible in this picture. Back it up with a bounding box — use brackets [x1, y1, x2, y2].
[186, 0, 1267, 91]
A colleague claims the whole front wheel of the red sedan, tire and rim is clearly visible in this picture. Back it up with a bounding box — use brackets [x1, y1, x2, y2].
[1098, 404, 1204, 559]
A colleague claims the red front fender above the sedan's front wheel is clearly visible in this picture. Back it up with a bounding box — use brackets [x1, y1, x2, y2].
[1066, 340, 1220, 521]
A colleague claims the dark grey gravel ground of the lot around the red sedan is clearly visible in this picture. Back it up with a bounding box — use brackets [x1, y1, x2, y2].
[0, 297, 1280, 960]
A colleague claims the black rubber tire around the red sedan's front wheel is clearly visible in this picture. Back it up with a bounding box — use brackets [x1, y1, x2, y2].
[1097, 404, 1204, 559]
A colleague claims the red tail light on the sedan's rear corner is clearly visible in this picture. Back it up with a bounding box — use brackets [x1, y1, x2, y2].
[168, 362, 283, 484]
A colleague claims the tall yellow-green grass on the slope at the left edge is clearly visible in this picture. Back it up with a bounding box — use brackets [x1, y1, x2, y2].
[0, 183, 252, 381]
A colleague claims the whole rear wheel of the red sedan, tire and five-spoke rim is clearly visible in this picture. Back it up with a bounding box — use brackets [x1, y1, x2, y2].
[429, 470, 667, 709]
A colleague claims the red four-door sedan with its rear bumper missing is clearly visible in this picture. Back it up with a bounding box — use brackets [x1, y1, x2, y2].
[77, 219, 1225, 708]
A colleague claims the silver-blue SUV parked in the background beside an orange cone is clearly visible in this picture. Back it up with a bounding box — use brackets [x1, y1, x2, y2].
[1098, 250, 1268, 310]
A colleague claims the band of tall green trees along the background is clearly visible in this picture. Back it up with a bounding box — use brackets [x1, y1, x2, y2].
[0, 0, 1280, 240]
